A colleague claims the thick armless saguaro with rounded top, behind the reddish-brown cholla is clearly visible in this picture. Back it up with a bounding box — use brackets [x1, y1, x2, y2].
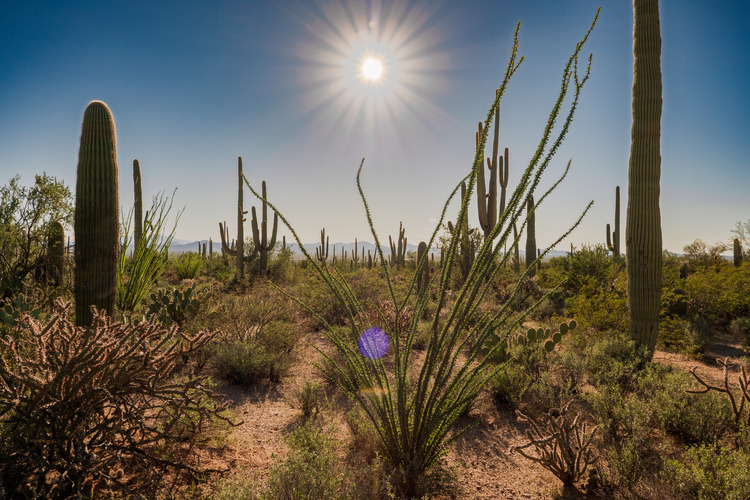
[73, 101, 120, 326]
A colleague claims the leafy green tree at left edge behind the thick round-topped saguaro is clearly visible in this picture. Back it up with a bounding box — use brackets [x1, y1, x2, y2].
[0, 173, 73, 298]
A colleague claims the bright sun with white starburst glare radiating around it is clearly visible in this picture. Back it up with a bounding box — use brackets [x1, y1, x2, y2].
[296, 0, 447, 159]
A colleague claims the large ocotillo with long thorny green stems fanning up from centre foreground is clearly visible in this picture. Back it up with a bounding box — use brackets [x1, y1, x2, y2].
[248, 12, 598, 496]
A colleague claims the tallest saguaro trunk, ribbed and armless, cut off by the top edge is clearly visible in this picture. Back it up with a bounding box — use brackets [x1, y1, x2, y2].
[625, 0, 662, 353]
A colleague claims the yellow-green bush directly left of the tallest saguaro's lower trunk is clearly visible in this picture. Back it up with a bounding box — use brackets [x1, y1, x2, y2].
[565, 273, 629, 333]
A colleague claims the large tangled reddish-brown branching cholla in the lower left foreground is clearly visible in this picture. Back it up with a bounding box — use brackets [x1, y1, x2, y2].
[0, 301, 231, 498]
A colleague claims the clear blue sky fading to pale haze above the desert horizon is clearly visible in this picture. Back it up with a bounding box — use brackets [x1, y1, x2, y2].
[0, 0, 750, 252]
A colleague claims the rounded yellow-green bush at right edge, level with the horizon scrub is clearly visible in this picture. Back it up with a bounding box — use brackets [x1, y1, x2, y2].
[684, 264, 750, 325]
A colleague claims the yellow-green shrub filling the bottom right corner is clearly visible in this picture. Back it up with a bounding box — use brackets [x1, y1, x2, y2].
[664, 444, 750, 500]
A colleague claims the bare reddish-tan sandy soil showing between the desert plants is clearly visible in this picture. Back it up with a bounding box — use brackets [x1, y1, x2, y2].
[197, 332, 742, 499]
